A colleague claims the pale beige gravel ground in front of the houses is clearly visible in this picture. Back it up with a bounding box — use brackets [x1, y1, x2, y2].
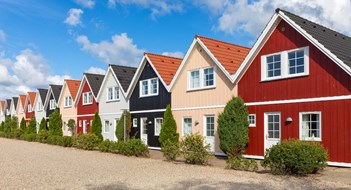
[0, 138, 351, 189]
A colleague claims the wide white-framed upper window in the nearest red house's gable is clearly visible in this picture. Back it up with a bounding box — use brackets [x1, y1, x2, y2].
[261, 47, 309, 81]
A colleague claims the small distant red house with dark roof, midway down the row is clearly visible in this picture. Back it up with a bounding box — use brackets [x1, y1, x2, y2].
[75, 73, 104, 134]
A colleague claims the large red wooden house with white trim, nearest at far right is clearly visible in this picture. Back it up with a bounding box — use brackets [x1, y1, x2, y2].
[233, 9, 351, 167]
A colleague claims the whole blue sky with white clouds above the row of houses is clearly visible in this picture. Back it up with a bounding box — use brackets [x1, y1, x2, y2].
[0, 0, 351, 99]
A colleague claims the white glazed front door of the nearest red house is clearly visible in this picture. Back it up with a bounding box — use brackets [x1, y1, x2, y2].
[264, 113, 281, 150]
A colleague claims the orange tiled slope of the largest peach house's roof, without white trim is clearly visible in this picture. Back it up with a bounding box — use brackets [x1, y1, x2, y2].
[196, 36, 250, 74]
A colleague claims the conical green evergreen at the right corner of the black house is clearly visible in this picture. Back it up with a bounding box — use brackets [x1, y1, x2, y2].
[158, 105, 179, 146]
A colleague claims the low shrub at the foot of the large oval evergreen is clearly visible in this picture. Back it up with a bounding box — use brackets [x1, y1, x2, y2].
[227, 156, 258, 172]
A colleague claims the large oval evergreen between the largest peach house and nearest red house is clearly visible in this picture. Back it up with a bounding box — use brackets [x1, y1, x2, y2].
[217, 97, 249, 157]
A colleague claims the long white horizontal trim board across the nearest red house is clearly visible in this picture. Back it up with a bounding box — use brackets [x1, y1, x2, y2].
[245, 95, 351, 106]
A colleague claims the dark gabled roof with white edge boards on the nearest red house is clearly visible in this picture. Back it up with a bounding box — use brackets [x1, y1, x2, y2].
[233, 9, 351, 83]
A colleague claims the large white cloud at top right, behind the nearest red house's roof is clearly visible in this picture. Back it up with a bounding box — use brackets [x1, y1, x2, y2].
[195, 0, 351, 36]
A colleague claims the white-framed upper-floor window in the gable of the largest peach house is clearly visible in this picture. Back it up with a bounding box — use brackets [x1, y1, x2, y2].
[188, 67, 215, 90]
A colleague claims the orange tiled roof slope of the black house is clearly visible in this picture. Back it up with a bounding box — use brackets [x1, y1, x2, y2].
[144, 53, 182, 85]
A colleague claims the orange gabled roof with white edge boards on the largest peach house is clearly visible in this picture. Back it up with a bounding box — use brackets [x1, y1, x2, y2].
[169, 35, 250, 90]
